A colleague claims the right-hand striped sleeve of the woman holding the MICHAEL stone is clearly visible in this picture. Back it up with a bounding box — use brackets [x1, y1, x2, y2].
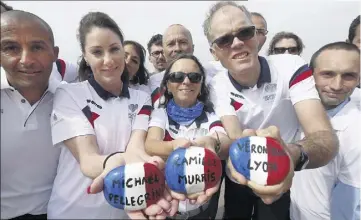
[132, 91, 153, 131]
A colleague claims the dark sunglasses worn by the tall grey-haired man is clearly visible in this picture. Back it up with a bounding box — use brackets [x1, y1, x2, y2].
[211, 26, 256, 48]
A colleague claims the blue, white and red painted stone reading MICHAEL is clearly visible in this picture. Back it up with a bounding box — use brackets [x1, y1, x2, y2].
[103, 163, 165, 211]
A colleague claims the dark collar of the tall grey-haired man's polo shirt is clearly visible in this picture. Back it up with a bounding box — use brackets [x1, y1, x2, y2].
[228, 56, 271, 92]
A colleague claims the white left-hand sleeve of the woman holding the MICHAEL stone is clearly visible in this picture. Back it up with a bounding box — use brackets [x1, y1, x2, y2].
[51, 84, 95, 145]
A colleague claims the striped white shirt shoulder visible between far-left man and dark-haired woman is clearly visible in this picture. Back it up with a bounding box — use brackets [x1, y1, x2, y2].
[51, 59, 79, 83]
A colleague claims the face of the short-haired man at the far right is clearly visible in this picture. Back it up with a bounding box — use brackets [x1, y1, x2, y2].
[313, 49, 360, 109]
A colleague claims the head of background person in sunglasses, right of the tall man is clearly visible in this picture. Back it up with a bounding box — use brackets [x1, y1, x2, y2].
[268, 32, 305, 55]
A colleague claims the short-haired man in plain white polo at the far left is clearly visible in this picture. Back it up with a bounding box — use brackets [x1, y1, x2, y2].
[1, 11, 60, 219]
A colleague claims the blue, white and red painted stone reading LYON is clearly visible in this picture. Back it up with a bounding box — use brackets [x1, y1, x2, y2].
[229, 136, 290, 185]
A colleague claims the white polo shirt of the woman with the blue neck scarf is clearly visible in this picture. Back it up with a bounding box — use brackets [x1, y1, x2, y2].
[149, 108, 226, 212]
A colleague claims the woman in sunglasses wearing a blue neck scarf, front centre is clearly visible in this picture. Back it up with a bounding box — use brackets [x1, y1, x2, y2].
[145, 55, 230, 219]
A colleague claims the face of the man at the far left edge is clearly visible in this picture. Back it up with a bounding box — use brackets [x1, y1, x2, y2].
[1, 16, 59, 90]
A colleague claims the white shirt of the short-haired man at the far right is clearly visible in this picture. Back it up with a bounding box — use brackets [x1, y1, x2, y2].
[290, 102, 361, 220]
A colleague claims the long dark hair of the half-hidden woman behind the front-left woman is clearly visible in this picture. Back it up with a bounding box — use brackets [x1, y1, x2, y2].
[124, 40, 149, 85]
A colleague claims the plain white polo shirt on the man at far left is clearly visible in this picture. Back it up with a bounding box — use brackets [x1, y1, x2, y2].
[1, 67, 60, 219]
